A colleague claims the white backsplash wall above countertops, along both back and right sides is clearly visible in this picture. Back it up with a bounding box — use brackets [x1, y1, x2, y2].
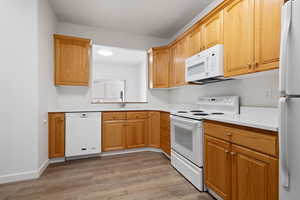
[56, 72, 279, 109]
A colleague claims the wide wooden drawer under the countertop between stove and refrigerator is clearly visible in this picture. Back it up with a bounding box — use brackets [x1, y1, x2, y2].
[204, 121, 278, 156]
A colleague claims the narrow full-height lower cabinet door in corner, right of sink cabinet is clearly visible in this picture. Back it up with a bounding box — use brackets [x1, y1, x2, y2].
[148, 112, 160, 148]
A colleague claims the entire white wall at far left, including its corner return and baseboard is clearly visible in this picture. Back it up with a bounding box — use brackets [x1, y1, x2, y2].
[0, 0, 56, 183]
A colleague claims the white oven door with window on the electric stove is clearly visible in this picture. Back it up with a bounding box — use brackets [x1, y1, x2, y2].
[171, 116, 203, 167]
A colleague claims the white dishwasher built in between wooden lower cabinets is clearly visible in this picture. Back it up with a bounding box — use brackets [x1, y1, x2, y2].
[66, 112, 101, 157]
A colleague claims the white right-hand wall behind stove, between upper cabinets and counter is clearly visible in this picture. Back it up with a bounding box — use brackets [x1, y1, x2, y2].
[169, 72, 279, 107]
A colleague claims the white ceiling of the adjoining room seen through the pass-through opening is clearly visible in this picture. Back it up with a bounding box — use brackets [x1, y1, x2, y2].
[93, 45, 147, 67]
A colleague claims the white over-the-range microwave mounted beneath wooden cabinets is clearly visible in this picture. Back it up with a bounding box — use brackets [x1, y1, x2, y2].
[185, 44, 225, 84]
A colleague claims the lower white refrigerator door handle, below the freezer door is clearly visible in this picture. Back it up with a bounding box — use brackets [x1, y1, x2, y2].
[279, 97, 290, 189]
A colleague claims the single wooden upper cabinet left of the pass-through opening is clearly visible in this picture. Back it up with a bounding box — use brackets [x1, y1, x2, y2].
[54, 35, 91, 86]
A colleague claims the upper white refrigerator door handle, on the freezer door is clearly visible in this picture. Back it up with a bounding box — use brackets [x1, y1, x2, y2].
[279, 1, 292, 95]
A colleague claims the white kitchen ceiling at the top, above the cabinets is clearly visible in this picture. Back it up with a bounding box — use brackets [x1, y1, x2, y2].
[49, 0, 212, 38]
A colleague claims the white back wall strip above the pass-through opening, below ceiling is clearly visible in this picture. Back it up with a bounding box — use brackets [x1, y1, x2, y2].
[57, 22, 168, 50]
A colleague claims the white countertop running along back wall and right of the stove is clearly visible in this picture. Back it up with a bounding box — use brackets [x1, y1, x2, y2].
[49, 105, 279, 132]
